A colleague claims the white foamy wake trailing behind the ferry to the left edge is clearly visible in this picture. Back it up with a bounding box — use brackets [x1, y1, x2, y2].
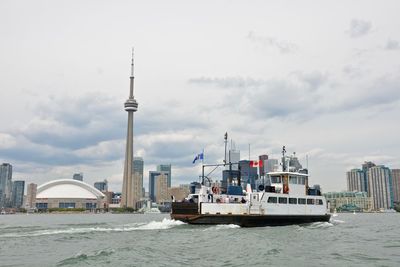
[0, 218, 185, 238]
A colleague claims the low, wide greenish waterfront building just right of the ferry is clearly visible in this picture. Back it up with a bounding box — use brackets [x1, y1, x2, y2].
[323, 191, 372, 212]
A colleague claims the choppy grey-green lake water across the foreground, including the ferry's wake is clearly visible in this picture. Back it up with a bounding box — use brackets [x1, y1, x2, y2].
[0, 214, 400, 267]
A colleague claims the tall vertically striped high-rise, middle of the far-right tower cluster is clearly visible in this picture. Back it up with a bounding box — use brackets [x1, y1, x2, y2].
[368, 165, 394, 210]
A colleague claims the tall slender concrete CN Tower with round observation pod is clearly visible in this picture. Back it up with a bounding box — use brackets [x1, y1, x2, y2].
[121, 49, 138, 208]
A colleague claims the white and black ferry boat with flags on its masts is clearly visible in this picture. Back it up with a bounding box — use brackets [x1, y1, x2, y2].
[171, 147, 331, 227]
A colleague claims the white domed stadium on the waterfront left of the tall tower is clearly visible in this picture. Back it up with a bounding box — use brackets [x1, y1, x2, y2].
[36, 179, 105, 210]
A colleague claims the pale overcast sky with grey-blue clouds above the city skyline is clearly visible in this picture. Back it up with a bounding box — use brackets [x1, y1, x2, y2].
[0, 0, 400, 192]
